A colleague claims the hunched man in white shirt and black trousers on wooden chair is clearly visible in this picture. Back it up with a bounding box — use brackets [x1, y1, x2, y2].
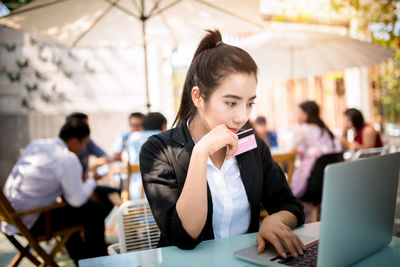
[1, 121, 106, 263]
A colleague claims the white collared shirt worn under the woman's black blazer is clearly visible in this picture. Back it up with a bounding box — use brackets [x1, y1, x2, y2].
[207, 157, 250, 239]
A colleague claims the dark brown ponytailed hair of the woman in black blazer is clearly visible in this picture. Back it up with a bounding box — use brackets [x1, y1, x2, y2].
[174, 30, 257, 125]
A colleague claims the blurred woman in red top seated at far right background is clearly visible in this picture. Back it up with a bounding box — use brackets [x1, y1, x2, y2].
[342, 108, 382, 150]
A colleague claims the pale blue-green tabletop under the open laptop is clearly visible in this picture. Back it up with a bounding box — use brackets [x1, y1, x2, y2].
[79, 223, 400, 267]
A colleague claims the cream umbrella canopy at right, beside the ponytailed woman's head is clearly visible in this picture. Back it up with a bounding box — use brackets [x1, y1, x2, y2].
[240, 29, 393, 79]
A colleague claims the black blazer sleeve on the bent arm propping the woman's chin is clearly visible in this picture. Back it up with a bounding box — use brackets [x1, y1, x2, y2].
[140, 136, 201, 249]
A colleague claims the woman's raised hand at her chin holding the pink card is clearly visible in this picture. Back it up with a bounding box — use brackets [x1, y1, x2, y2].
[195, 124, 239, 159]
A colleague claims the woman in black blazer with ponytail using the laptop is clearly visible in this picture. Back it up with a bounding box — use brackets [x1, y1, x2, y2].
[140, 30, 304, 257]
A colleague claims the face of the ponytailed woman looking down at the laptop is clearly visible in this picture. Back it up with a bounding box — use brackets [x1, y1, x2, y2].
[198, 73, 257, 133]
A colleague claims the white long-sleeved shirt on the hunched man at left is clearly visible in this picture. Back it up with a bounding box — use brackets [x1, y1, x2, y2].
[1, 137, 96, 234]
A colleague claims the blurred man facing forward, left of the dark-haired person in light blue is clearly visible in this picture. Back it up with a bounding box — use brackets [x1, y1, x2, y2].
[113, 112, 143, 161]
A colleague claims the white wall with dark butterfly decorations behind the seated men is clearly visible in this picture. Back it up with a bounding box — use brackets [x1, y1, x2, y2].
[0, 25, 175, 185]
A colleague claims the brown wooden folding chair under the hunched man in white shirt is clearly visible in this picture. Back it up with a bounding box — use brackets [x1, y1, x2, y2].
[0, 190, 84, 266]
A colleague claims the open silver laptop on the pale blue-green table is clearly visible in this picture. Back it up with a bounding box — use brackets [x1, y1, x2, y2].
[234, 153, 400, 267]
